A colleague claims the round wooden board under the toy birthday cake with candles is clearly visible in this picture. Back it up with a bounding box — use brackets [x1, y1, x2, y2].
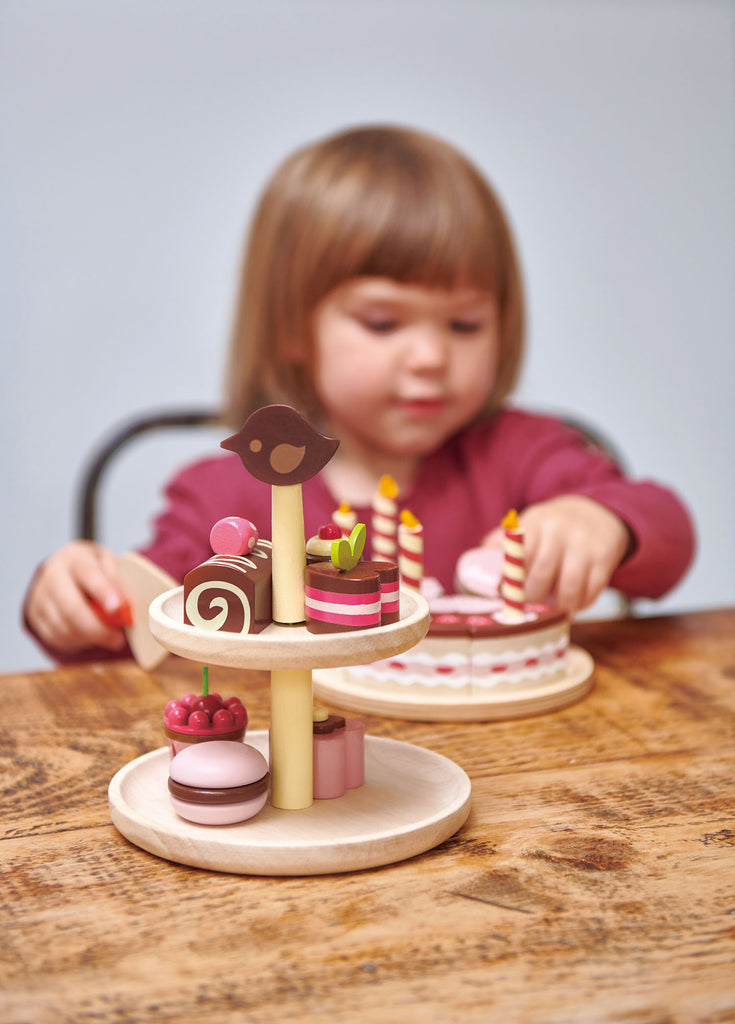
[312, 645, 595, 722]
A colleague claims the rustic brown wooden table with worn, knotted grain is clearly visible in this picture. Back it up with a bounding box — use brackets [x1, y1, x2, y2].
[0, 609, 735, 1024]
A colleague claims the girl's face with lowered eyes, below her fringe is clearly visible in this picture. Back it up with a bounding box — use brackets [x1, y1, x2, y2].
[313, 278, 499, 457]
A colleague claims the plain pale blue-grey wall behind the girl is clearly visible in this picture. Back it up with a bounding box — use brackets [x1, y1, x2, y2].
[0, 0, 735, 671]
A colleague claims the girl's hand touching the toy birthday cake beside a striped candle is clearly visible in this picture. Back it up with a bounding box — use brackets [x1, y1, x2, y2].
[483, 495, 631, 614]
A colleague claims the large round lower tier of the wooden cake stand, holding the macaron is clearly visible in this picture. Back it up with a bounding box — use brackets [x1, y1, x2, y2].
[109, 730, 471, 876]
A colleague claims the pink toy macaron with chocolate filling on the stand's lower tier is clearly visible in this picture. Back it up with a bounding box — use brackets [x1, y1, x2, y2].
[169, 739, 270, 825]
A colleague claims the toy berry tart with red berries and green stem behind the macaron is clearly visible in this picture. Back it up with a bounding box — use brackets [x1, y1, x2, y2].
[164, 666, 248, 758]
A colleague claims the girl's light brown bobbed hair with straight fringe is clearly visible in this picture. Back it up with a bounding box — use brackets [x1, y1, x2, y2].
[224, 126, 524, 426]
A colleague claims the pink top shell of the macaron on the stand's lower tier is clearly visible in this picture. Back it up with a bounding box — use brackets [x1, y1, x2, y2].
[170, 739, 268, 790]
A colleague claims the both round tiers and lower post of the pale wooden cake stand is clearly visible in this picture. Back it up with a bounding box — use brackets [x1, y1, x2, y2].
[109, 587, 471, 876]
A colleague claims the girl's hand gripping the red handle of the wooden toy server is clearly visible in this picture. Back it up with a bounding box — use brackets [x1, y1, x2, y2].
[26, 541, 126, 653]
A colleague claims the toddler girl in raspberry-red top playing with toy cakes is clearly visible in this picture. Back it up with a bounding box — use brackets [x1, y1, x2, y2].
[26, 127, 694, 658]
